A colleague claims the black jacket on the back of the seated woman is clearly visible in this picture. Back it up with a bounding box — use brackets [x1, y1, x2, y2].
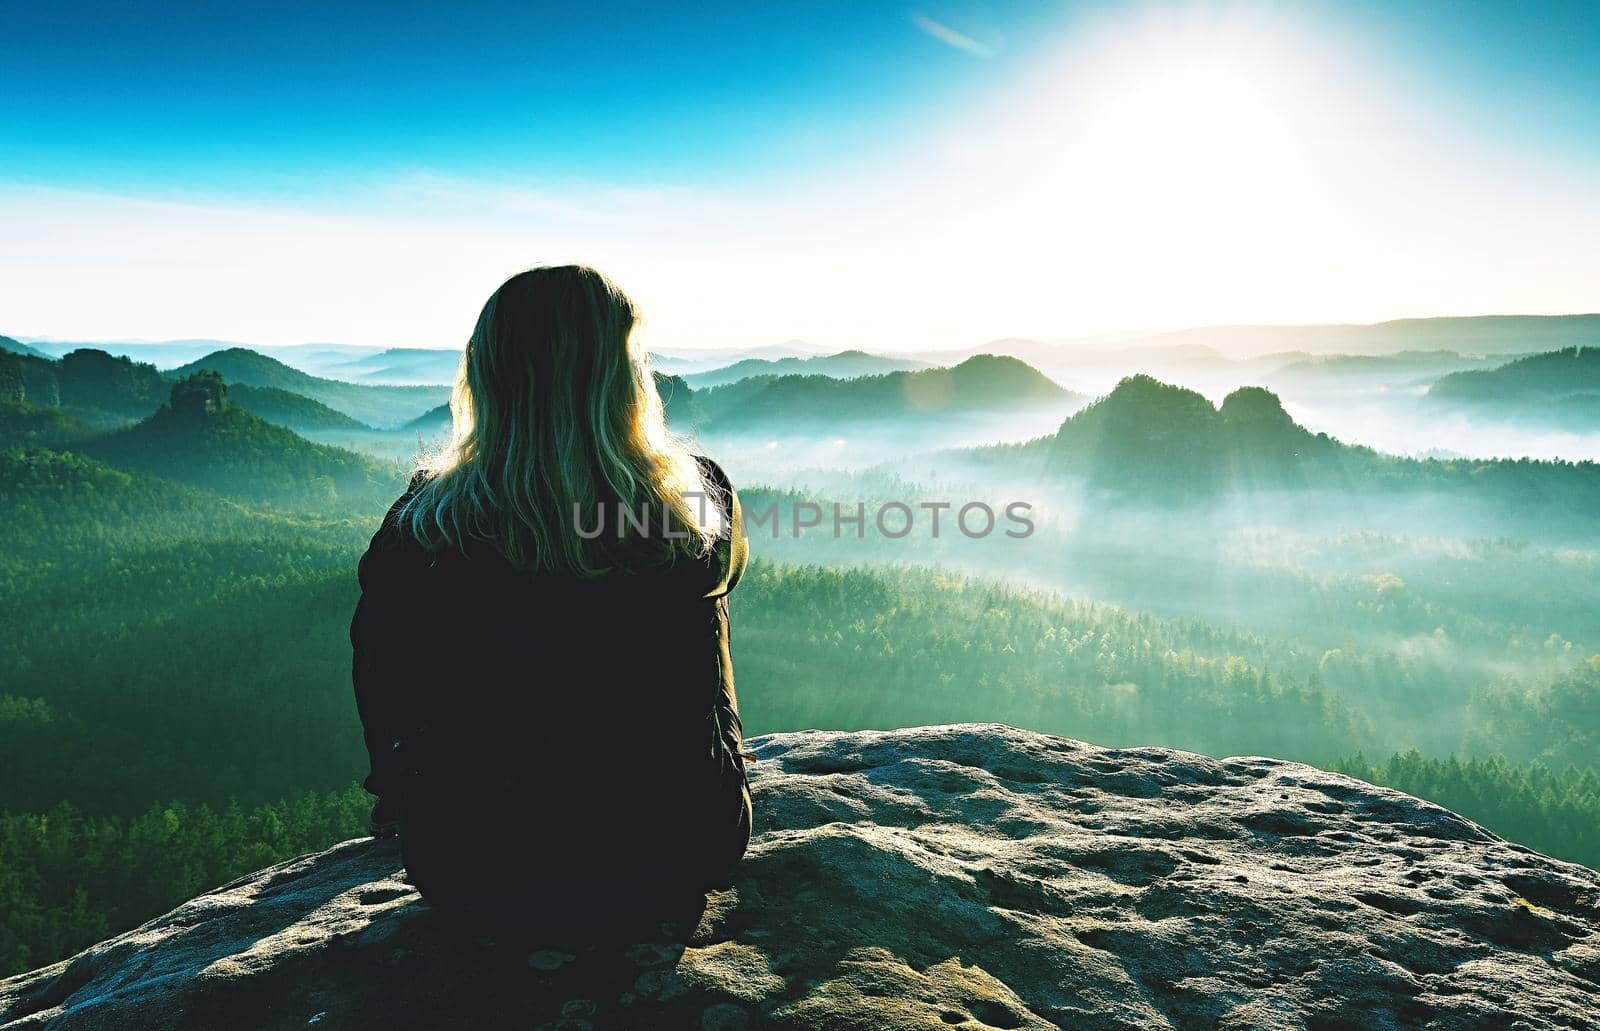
[350, 459, 749, 921]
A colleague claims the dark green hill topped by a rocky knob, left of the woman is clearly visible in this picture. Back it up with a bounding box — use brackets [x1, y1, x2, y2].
[80, 371, 405, 509]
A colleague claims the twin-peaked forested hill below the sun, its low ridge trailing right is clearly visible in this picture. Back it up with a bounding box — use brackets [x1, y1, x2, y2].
[968, 375, 1600, 520]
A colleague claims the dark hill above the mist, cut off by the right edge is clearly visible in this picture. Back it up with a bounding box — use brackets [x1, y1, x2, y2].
[1427, 346, 1600, 431]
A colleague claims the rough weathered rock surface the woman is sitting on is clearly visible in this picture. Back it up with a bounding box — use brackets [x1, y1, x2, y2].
[0, 725, 1600, 1031]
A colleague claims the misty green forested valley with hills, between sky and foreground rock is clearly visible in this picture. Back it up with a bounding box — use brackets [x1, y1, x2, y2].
[0, 319, 1600, 970]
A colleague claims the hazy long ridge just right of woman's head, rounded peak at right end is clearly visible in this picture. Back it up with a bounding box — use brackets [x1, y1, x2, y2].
[694, 354, 1082, 431]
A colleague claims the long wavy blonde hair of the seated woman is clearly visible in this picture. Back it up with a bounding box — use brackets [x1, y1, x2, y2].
[400, 266, 722, 576]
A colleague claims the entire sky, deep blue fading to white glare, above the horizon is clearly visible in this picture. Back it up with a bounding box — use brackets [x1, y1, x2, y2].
[0, 2, 1600, 346]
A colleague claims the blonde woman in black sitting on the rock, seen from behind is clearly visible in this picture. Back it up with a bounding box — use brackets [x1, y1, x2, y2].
[350, 266, 750, 940]
